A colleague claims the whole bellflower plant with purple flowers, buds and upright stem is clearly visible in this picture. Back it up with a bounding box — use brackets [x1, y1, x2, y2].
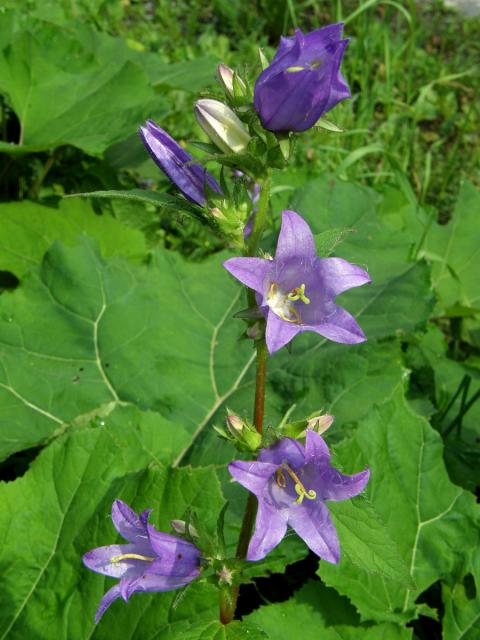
[83, 24, 380, 624]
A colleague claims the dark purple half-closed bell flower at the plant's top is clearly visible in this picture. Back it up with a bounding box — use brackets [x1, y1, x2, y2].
[254, 22, 350, 131]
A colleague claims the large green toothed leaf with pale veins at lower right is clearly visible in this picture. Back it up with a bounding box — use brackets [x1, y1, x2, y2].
[319, 386, 479, 622]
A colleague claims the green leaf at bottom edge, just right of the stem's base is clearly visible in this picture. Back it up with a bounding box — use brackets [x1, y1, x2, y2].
[246, 581, 412, 640]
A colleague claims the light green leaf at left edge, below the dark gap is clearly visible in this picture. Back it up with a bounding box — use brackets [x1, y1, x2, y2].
[0, 200, 146, 278]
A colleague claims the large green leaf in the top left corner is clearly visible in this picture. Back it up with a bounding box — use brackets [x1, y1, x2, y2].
[0, 13, 167, 155]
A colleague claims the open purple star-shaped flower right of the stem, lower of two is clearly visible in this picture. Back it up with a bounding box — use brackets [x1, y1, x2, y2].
[228, 429, 370, 563]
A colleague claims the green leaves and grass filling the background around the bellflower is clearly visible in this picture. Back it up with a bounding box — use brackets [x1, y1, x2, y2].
[0, 0, 480, 640]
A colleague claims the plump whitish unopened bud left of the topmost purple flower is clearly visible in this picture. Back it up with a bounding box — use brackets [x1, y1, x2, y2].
[195, 98, 250, 154]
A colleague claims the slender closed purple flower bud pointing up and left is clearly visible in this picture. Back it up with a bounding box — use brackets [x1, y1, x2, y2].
[138, 120, 222, 207]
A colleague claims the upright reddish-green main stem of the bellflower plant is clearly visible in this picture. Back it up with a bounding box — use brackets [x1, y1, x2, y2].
[220, 175, 270, 624]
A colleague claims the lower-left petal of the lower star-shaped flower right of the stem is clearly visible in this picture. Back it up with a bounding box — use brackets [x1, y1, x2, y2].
[247, 500, 287, 562]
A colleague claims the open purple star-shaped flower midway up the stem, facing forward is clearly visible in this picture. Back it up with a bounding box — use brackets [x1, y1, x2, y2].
[223, 211, 370, 353]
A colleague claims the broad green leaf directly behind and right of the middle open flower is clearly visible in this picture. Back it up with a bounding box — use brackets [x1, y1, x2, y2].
[290, 176, 434, 339]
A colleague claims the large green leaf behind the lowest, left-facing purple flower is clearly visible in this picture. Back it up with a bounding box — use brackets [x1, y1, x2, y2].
[0, 407, 227, 640]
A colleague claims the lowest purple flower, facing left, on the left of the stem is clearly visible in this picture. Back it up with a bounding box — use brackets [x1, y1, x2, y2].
[83, 500, 200, 622]
